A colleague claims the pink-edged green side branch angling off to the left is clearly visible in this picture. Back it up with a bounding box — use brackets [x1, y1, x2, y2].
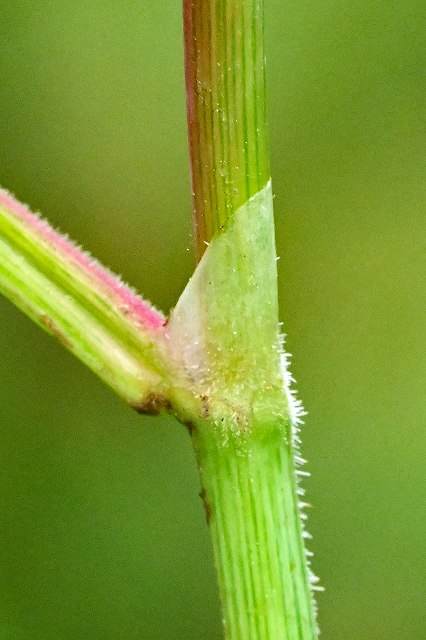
[0, 190, 167, 408]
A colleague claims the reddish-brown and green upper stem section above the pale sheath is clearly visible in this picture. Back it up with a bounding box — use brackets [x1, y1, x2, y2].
[184, 0, 269, 257]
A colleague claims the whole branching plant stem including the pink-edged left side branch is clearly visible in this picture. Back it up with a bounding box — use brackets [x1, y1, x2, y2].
[0, 5, 317, 640]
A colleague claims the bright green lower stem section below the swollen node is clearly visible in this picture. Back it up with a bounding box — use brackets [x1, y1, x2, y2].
[194, 429, 316, 640]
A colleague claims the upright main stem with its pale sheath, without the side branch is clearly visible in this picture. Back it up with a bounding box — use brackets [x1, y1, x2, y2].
[181, 0, 317, 640]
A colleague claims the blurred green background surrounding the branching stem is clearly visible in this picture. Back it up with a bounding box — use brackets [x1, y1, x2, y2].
[0, 0, 426, 640]
